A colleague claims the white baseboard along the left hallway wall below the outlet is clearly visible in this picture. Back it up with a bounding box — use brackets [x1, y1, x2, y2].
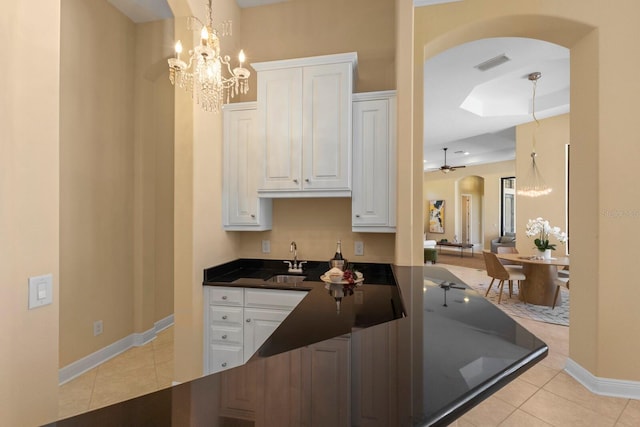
[58, 314, 173, 385]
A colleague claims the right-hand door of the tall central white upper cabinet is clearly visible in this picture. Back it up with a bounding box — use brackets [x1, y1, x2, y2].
[302, 63, 352, 191]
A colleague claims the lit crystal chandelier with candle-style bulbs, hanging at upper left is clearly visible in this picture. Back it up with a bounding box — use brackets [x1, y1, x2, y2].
[168, 0, 251, 113]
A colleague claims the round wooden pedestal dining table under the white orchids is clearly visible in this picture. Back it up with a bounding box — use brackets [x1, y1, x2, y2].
[496, 253, 569, 307]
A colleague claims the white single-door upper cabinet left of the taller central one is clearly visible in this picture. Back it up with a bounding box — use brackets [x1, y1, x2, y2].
[222, 102, 271, 231]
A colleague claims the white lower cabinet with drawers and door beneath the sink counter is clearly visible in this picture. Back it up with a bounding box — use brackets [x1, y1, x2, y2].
[203, 286, 307, 375]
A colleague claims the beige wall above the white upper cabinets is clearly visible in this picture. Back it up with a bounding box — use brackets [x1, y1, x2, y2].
[241, 0, 396, 94]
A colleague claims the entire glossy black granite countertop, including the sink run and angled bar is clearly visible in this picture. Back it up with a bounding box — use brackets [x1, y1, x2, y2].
[46, 259, 548, 426]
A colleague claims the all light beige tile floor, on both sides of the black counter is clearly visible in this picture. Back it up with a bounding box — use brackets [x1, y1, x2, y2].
[59, 264, 640, 427]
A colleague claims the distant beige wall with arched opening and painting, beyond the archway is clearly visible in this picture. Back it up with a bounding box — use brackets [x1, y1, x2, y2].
[423, 161, 519, 249]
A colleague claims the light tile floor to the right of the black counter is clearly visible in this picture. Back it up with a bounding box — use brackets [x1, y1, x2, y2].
[439, 264, 640, 427]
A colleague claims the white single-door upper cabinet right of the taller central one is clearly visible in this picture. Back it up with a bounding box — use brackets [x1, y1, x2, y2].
[351, 91, 396, 233]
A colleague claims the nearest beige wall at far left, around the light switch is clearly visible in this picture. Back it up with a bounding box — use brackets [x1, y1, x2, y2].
[0, 0, 61, 426]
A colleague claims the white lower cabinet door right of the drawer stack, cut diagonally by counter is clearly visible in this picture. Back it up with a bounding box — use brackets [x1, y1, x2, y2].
[244, 308, 290, 362]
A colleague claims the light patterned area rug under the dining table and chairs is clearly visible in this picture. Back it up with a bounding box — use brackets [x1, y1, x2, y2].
[438, 263, 570, 326]
